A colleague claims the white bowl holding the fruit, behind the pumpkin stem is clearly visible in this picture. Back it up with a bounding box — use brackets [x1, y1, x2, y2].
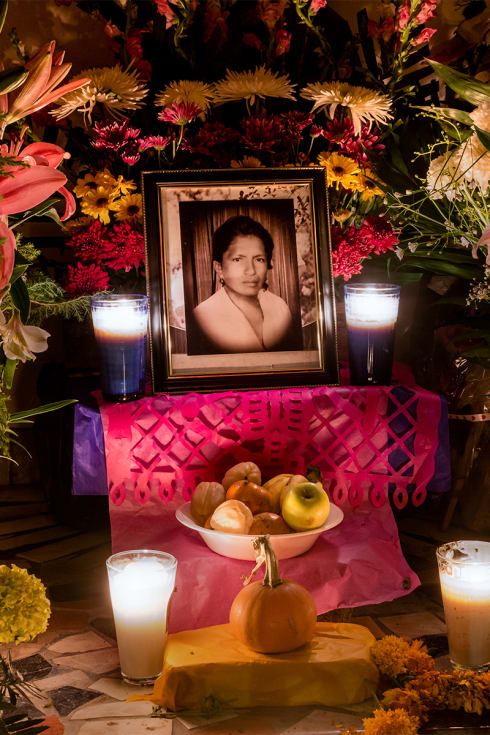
[175, 503, 344, 561]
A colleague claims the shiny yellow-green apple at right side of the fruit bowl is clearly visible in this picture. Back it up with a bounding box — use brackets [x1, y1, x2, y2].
[281, 482, 330, 531]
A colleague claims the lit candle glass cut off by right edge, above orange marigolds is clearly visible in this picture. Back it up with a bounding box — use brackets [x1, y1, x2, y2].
[436, 541, 490, 670]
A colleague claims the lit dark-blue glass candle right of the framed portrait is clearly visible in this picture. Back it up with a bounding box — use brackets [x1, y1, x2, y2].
[344, 283, 400, 385]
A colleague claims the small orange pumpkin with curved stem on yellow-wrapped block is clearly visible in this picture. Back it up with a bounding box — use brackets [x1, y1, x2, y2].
[230, 536, 317, 653]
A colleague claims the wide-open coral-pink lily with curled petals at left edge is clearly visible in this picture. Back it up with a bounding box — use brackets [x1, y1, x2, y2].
[0, 142, 76, 220]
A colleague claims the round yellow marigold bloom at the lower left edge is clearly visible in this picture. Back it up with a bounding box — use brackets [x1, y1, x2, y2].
[0, 564, 51, 643]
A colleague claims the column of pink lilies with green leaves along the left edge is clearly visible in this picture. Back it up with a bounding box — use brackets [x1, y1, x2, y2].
[0, 2, 94, 460]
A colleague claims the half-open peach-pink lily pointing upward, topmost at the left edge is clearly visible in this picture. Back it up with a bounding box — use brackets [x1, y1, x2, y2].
[0, 41, 89, 132]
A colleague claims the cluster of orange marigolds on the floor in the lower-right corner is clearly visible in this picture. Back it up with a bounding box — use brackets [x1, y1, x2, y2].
[342, 635, 490, 735]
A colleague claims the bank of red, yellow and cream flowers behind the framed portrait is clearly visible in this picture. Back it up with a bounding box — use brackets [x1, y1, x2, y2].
[42, 0, 464, 293]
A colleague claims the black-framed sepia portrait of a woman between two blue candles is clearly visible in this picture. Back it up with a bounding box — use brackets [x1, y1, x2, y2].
[142, 166, 338, 392]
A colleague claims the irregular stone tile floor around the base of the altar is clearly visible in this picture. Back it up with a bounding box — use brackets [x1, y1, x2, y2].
[0, 489, 490, 735]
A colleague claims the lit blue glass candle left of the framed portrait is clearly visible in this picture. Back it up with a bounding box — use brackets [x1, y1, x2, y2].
[90, 294, 148, 402]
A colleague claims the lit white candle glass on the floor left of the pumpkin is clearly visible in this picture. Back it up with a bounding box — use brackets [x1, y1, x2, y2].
[106, 549, 177, 685]
